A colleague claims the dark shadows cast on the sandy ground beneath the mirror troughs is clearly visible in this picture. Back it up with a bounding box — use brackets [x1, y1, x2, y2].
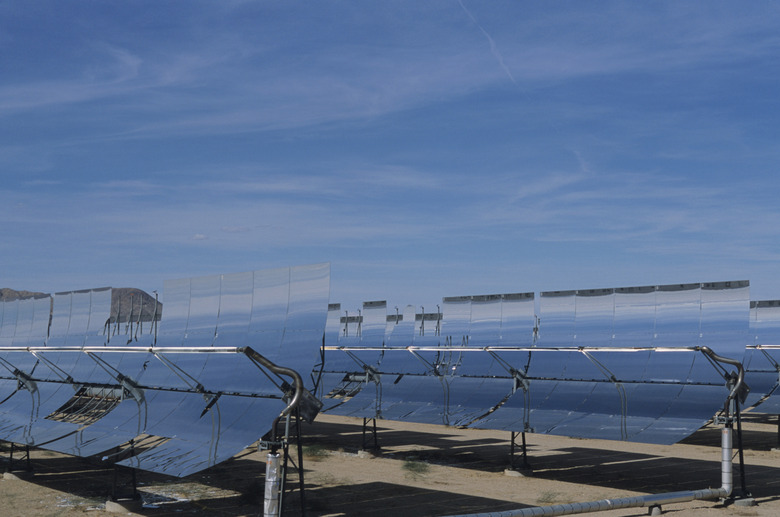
[2, 415, 780, 517]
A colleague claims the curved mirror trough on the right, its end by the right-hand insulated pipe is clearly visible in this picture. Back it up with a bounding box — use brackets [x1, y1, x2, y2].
[325, 281, 749, 443]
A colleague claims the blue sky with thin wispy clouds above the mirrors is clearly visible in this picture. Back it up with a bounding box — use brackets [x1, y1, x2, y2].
[0, 0, 780, 307]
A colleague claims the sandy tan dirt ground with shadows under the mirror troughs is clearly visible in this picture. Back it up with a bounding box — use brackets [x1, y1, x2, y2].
[0, 414, 780, 517]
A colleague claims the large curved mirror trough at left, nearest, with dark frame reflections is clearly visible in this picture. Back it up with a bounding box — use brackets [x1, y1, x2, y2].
[0, 264, 330, 476]
